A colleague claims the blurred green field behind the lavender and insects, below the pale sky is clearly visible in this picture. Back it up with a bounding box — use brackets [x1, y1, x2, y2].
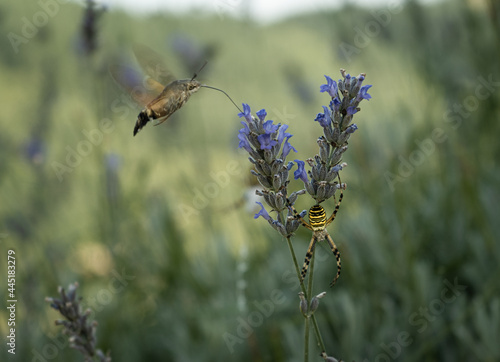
[0, 0, 500, 362]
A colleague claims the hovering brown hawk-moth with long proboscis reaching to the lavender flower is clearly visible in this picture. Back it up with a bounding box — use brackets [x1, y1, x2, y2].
[110, 46, 241, 136]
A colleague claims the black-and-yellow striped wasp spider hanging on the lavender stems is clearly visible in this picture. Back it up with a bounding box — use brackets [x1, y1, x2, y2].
[288, 188, 344, 287]
